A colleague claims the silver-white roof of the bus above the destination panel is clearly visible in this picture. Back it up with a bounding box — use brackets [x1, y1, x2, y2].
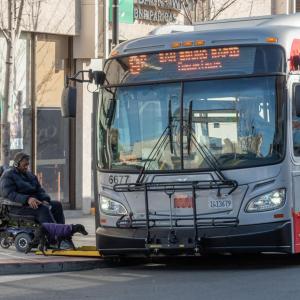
[115, 13, 300, 55]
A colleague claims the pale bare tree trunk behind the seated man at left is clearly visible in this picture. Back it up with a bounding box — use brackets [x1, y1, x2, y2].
[0, 0, 25, 166]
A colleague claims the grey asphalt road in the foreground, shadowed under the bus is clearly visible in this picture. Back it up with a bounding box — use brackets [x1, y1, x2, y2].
[0, 255, 300, 300]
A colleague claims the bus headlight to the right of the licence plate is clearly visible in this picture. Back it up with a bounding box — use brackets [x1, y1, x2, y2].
[245, 189, 285, 212]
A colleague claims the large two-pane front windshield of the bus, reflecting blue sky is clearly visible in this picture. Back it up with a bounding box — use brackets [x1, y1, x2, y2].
[98, 75, 285, 172]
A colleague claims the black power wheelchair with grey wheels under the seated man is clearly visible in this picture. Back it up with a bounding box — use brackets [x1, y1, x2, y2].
[0, 197, 39, 252]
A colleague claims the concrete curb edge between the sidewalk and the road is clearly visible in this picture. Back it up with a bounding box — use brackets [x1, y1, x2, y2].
[0, 258, 107, 275]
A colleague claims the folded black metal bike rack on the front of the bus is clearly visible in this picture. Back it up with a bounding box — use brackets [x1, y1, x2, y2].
[113, 180, 239, 252]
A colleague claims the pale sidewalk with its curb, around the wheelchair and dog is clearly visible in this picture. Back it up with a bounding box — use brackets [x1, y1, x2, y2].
[0, 211, 104, 275]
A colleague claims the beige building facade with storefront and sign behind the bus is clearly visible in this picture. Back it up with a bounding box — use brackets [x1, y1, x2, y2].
[0, 0, 300, 213]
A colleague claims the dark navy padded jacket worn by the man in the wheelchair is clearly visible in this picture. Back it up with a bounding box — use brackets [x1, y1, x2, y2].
[0, 167, 50, 204]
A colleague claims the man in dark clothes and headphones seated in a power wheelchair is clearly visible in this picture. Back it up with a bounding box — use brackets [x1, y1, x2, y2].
[0, 152, 65, 224]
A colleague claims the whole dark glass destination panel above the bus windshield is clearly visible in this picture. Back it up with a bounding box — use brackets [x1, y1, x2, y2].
[105, 45, 285, 85]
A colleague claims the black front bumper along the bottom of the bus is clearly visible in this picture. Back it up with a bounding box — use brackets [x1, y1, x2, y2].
[96, 221, 293, 255]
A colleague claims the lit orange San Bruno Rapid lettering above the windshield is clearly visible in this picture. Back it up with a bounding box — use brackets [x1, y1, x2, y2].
[128, 47, 240, 75]
